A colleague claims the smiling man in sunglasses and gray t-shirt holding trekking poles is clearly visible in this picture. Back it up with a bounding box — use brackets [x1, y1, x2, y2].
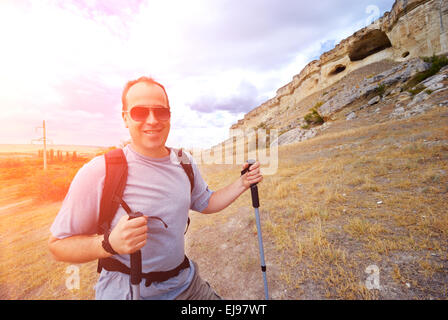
[49, 77, 263, 299]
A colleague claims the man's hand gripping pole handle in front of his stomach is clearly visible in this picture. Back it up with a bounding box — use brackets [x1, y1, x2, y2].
[109, 215, 148, 254]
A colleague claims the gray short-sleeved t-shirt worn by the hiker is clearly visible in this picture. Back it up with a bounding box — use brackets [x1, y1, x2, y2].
[50, 145, 213, 299]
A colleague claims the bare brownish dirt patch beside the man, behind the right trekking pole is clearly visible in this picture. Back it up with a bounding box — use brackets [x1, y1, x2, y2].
[187, 205, 288, 300]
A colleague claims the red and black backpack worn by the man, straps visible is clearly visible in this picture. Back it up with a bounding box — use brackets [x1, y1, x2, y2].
[97, 148, 194, 272]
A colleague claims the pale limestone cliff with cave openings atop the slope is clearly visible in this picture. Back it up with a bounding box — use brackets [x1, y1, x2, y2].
[230, 0, 448, 137]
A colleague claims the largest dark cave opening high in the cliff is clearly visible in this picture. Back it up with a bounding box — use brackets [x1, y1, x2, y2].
[348, 30, 392, 61]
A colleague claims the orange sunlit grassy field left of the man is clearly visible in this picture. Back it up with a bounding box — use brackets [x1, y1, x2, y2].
[0, 150, 97, 299]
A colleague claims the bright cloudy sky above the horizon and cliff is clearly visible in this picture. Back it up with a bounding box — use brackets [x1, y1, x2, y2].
[0, 0, 394, 148]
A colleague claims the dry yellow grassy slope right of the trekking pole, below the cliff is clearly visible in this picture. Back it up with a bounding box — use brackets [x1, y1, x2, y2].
[191, 109, 448, 299]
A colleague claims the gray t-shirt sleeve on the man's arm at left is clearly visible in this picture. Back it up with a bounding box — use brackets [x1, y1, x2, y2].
[50, 156, 105, 239]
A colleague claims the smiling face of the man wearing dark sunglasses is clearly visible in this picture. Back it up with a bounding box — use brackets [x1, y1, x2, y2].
[123, 82, 170, 157]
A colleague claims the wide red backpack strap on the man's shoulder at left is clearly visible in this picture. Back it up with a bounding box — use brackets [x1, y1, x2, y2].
[98, 148, 128, 234]
